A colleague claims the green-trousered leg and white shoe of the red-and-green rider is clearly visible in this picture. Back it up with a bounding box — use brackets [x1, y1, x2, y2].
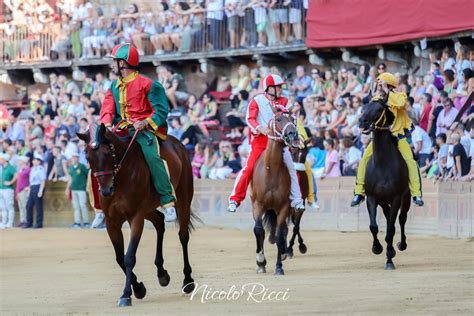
[136, 131, 176, 220]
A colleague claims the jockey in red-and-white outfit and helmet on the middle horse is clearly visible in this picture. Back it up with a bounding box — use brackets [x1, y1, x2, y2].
[227, 74, 305, 212]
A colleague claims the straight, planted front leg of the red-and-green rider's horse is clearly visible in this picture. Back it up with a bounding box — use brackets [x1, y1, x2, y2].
[119, 215, 146, 306]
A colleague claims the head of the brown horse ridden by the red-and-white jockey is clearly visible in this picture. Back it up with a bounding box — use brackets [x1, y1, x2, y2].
[269, 111, 301, 147]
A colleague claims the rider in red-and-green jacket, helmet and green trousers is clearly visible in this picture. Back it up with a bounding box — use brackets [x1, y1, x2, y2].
[100, 43, 176, 221]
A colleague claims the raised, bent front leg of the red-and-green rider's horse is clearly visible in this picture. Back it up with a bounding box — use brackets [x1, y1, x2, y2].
[105, 217, 146, 306]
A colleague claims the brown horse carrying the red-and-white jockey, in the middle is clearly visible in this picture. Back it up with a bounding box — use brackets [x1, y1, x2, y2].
[251, 112, 300, 275]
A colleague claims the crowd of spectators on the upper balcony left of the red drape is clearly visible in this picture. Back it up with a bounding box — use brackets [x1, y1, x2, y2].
[0, 0, 308, 62]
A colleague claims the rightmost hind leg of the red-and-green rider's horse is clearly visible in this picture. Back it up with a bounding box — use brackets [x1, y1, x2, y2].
[176, 199, 195, 294]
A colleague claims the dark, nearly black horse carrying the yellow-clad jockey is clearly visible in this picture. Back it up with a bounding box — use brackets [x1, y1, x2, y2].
[359, 100, 410, 270]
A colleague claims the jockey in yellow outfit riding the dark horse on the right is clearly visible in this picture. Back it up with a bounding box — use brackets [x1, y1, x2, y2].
[351, 72, 424, 207]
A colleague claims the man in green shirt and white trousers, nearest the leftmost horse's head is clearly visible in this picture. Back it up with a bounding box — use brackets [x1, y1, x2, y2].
[66, 152, 90, 228]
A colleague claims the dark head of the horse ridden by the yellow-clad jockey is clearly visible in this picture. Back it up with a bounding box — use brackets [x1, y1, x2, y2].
[359, 100, 395, 134]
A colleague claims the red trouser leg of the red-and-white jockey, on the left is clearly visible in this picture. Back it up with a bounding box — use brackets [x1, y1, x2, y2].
[229, 135, 268, 205]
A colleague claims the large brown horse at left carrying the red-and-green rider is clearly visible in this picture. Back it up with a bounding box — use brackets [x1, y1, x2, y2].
[77, 124, 194, 306]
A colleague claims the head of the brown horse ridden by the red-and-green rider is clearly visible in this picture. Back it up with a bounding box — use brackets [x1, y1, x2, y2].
[77, 123, 117, 196]
